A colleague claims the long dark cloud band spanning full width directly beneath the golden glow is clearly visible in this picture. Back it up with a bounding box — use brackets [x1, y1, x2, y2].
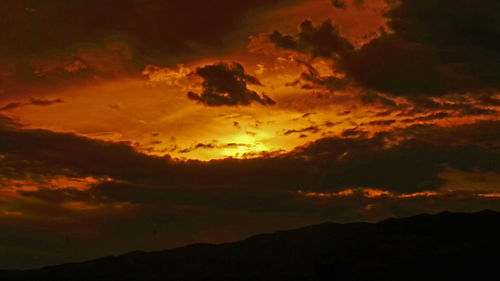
[0, 120, 500, 195]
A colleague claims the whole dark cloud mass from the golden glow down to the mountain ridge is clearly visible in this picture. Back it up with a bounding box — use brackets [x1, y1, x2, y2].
[0, 121, 500, 267]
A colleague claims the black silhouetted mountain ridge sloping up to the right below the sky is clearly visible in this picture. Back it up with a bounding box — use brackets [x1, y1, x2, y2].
[0, 211, 500, 281]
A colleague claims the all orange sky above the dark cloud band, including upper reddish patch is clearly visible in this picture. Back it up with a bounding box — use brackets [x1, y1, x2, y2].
[5, 0, 496, 160]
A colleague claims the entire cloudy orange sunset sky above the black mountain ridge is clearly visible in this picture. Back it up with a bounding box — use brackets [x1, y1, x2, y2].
[0, 0, 500, 269]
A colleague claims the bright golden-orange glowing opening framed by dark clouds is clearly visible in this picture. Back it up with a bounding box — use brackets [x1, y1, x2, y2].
[2, 56, 492, 160]
